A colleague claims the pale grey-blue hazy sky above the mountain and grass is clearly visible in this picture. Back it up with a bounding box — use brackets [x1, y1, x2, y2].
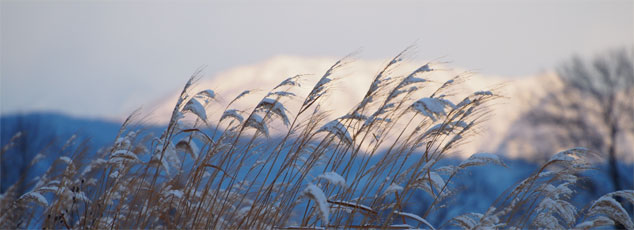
[0, 0, 634, 118]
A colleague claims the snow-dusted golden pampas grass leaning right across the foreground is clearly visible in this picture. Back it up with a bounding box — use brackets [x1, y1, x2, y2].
[0, 51, 634, 229]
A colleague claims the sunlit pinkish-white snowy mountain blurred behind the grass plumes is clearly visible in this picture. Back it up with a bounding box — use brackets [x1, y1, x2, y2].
[145, 56, 552, 160]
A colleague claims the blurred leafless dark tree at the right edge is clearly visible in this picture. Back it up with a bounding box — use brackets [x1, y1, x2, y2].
[526, 49, 634, 190]
